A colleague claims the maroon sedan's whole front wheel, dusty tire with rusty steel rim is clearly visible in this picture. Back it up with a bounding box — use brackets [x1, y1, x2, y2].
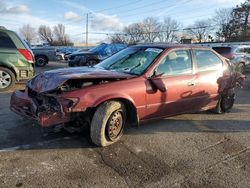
[90, 101, 126, 147]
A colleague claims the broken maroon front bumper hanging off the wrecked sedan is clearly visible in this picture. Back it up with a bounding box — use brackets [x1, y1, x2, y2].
[10, 90, 71, 127]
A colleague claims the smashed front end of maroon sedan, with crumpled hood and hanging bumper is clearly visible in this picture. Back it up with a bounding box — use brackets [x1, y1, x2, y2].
[10, 68, 132, 127]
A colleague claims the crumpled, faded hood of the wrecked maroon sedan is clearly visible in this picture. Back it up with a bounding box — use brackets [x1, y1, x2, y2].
[27, 67, 134, 93]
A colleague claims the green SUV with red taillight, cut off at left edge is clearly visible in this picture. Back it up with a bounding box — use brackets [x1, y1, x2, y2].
[0, 28, 34, 92]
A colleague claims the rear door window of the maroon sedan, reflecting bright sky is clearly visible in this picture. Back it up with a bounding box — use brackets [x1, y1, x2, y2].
[194, 50, 223, 72]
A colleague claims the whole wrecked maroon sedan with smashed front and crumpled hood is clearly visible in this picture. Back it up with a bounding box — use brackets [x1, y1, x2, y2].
[11, 45, 243, 146]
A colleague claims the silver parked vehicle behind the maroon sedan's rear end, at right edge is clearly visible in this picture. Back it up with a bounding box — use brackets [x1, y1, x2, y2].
[213, 46, 250, 73]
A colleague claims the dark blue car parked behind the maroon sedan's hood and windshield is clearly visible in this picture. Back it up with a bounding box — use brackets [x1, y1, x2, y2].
[68, 43, 127, 67]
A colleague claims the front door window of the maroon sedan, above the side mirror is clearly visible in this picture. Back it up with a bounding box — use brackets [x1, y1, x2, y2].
[156, 50, 193, 76]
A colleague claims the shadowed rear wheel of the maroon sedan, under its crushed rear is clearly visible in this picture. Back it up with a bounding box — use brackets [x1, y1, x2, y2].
[212, 94, 235, 114]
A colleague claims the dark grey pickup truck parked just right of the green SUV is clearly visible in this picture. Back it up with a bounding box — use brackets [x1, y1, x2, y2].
[32, 47, 57, 67]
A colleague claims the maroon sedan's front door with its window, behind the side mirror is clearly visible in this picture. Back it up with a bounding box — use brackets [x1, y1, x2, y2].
[145, 49, 199, 119]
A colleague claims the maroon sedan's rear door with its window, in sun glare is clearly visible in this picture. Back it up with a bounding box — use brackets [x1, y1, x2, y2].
[193, 49, 223, 109]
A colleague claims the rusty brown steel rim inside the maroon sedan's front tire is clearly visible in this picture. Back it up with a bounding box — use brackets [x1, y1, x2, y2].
[106, 111, 124, 141]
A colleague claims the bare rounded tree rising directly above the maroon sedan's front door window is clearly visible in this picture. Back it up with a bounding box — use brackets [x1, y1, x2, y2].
[158, 17, 181, 42]
